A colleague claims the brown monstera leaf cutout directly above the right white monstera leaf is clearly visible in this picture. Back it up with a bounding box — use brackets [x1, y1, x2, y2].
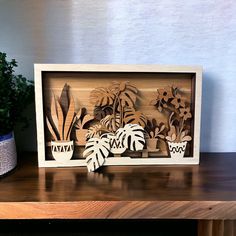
[124, 108, 147, 128]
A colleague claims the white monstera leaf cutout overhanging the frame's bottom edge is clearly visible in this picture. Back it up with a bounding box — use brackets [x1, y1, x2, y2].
[83, 138, 110, 172]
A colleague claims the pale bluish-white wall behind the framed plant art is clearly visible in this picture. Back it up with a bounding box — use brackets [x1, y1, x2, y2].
[0, 0, 236, 152]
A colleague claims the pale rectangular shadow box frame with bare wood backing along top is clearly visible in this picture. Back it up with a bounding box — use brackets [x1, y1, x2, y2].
[34, 64, 202, 167]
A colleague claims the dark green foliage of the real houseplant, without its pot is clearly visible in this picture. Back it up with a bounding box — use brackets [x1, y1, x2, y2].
[0, 52, 34, 136]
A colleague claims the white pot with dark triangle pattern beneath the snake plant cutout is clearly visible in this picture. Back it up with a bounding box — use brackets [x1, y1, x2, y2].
[51, 141, 74, 164]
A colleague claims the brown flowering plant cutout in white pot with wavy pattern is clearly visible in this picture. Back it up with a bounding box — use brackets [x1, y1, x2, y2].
[152, 87, 192, 158]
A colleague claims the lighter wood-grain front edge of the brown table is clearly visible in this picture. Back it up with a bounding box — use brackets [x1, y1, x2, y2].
[0, 201, 236, 220]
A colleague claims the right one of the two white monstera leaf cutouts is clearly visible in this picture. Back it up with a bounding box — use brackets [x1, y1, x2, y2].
[116, 124, 145, 151]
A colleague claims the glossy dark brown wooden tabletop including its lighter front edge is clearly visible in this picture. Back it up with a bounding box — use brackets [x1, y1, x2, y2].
[0, 153, 236, 219]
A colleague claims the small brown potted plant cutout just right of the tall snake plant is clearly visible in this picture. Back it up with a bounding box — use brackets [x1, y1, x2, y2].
[75, 108, 94, 146]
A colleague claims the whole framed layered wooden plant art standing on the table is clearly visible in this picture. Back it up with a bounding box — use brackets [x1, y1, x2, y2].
[35, 64, 202, 168]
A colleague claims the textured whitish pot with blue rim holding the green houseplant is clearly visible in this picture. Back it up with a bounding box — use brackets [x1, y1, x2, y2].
[0, 132, 17, 175]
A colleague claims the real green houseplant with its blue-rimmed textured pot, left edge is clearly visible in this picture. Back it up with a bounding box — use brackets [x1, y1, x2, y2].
[0, 52, 34, 175]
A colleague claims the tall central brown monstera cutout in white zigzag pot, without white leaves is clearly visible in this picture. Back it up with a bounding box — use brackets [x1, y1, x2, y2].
[90, 81, 147, 154]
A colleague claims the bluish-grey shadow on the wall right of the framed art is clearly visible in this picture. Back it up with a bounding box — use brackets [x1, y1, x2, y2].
[200, 72, 216, 152]
